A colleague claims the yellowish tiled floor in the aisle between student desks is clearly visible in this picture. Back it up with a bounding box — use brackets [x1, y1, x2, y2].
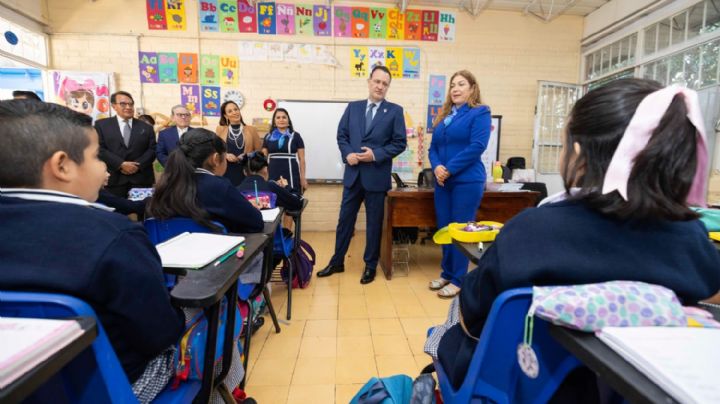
[246, 232, 449, 404]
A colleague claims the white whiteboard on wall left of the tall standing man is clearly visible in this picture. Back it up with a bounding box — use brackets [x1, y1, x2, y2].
[278, 100, 348, 181]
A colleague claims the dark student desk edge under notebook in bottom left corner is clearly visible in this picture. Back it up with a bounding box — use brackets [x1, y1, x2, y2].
[0, 317, 97, 403]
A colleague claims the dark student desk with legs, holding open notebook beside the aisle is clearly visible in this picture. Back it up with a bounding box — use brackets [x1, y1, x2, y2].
[170, 233, 272, 403]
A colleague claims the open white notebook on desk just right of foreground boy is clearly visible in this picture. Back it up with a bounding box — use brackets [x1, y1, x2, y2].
[155, 233, 245, 269]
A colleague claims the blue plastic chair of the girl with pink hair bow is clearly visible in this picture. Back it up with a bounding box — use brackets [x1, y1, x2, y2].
[434, 288, 581, 404]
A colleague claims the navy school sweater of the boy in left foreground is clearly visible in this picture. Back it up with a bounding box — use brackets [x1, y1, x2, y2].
[0, 190, 185, 383]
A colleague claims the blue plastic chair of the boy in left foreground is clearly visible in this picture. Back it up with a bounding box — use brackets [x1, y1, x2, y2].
[0, 291, 200, 404]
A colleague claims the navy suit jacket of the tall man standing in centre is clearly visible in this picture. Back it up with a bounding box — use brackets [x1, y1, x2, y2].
[337, 100, 407, 192]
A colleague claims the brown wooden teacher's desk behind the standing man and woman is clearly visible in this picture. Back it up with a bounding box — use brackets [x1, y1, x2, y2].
[380, 188, 540, 280]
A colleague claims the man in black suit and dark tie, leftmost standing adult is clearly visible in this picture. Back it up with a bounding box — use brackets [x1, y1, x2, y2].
[95, 91, 155, 198]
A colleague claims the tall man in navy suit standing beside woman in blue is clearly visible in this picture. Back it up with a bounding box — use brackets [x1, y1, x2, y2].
[318, 66, 407, 284]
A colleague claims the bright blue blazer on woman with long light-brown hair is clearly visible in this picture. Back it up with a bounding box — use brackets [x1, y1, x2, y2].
[429, 104, 491, 184]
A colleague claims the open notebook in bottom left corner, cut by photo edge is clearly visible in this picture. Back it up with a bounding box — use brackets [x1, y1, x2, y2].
[0, 317, 83, 389]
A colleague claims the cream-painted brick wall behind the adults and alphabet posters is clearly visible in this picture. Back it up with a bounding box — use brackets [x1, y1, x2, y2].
[48, 0, 583, 230]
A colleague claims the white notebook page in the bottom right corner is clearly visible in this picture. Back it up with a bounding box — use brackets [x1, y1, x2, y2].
[597, 327, 720, 403]
